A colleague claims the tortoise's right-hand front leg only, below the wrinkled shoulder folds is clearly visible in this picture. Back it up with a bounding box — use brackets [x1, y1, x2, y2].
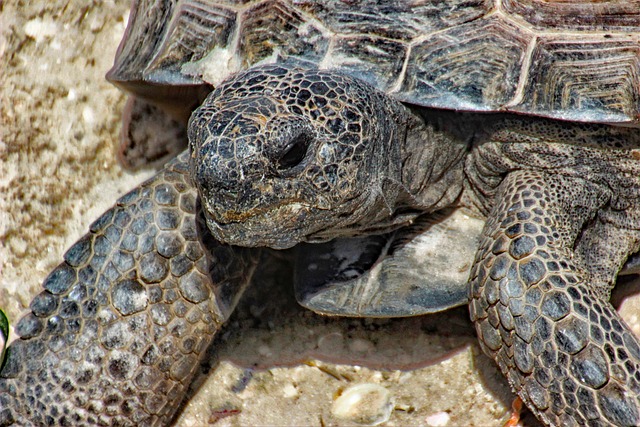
[469, 171, 640, 426]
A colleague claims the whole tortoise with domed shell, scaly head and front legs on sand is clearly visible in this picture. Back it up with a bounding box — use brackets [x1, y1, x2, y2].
[0, 0, 640, 425]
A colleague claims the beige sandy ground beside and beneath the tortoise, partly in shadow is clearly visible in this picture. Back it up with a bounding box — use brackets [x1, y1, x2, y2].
[0, 0, 638, 426]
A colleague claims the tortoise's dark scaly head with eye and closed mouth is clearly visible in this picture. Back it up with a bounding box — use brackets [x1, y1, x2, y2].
[189, 65, 407, 249]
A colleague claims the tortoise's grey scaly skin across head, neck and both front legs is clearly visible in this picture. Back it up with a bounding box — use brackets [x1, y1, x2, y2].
[0, 66, 640, 425]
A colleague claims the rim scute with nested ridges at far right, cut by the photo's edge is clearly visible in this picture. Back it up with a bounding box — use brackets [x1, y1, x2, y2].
[513, 37, 640, 122]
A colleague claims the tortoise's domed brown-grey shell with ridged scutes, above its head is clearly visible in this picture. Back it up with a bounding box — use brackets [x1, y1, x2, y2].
[107, 0, 640, 125]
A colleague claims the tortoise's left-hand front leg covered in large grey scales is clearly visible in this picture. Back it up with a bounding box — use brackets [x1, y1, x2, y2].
[0, 155, 260, 426]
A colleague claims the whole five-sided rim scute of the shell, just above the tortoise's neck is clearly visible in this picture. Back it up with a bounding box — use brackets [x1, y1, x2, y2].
[398, 17, 530, 111]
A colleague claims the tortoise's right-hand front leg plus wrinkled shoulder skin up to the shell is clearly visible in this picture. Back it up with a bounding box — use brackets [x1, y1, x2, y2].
[468, 122, 640, 426]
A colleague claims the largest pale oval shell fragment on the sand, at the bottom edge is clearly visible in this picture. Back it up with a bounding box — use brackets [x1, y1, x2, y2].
[331, 384, 394, 426]
